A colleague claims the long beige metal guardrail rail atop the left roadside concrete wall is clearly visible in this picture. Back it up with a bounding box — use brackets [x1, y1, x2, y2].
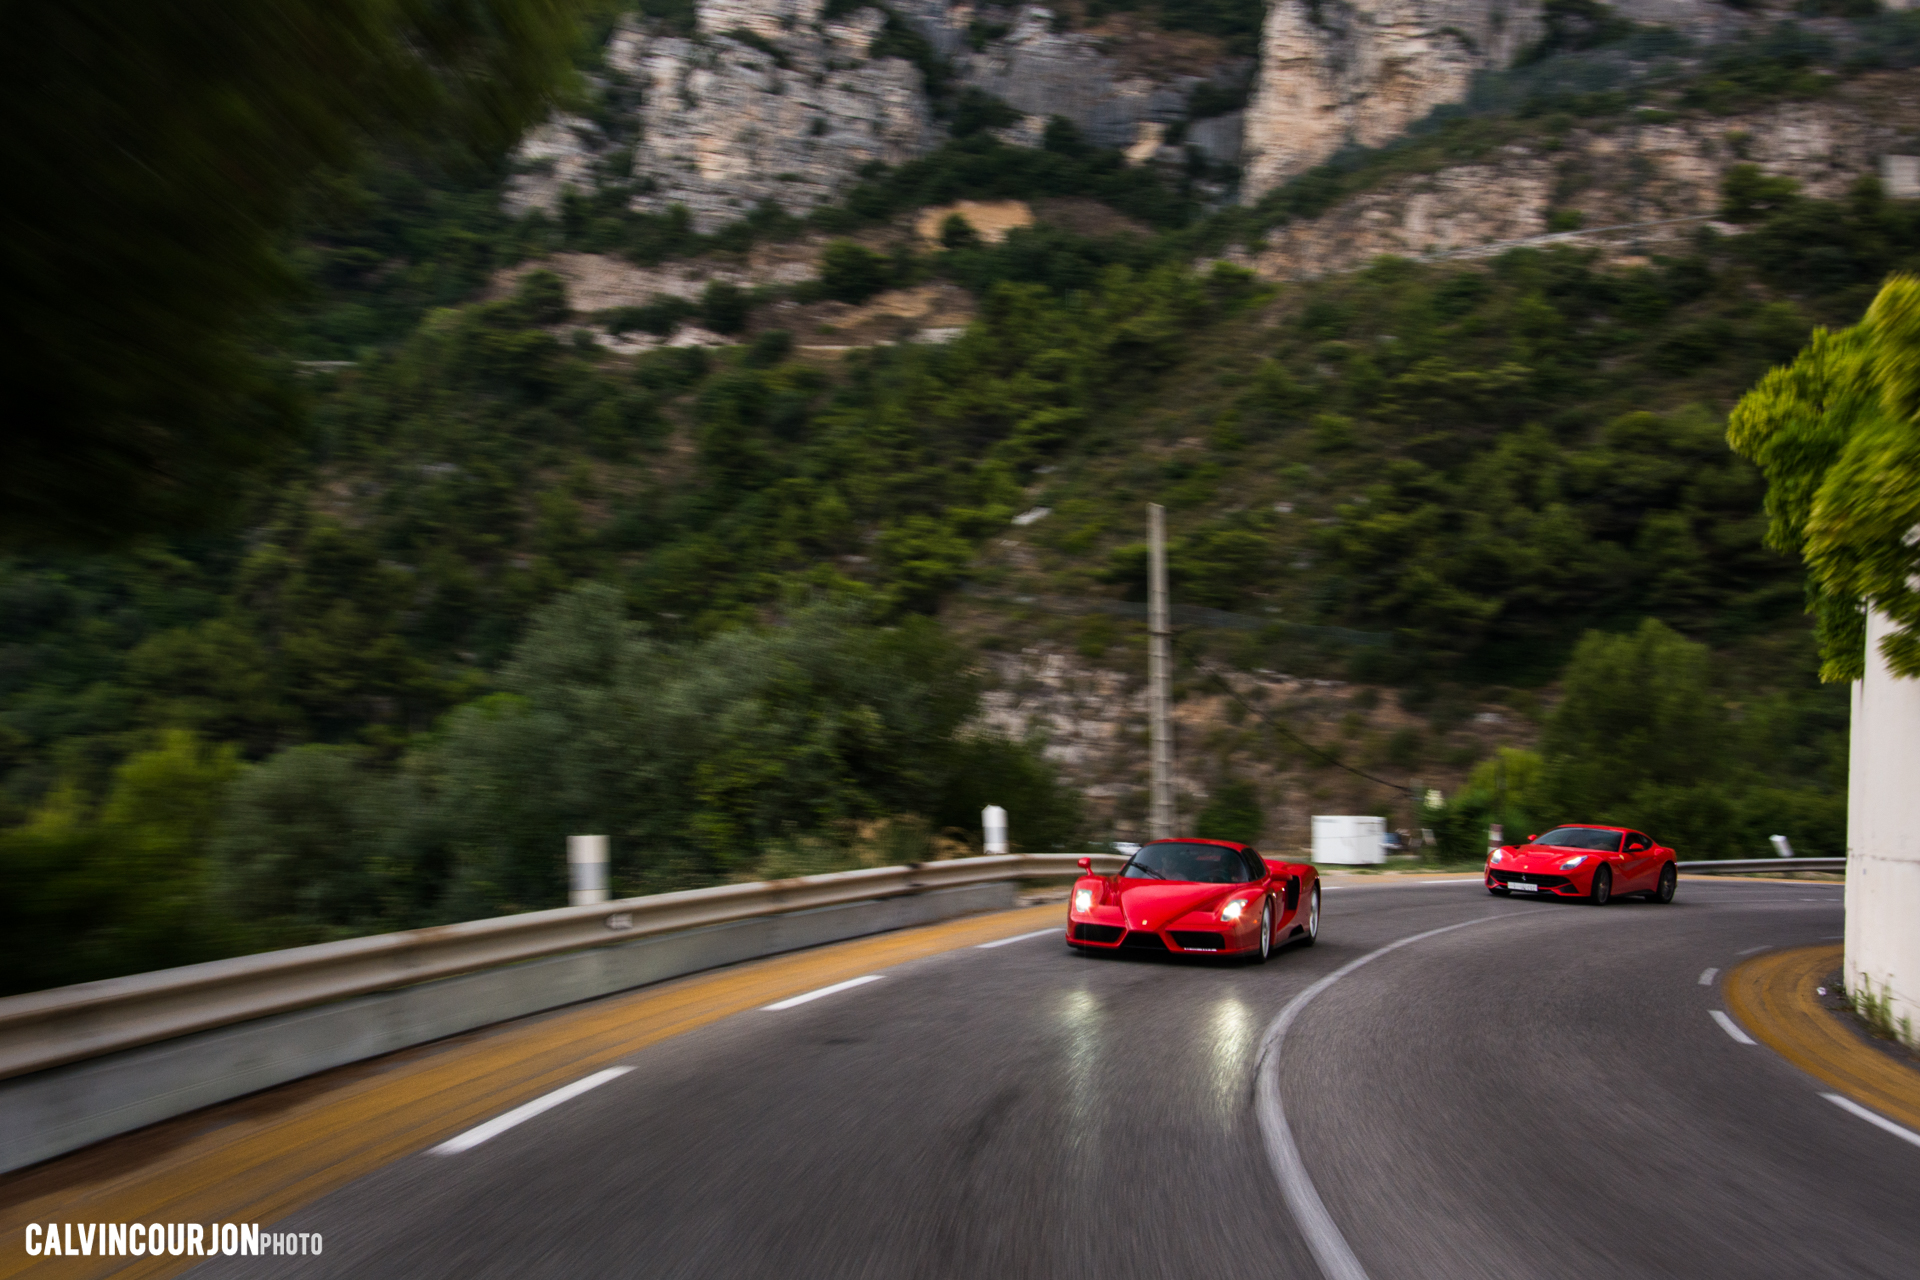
[0, 854, 1125, 1079]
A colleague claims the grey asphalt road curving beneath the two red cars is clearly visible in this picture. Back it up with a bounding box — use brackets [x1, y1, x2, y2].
[194, 881, 1920, 1280]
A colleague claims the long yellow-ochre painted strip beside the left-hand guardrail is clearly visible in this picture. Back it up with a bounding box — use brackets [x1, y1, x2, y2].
[0, 904, 1066, 1278]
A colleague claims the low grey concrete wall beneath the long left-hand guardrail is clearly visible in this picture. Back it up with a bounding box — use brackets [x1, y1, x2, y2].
[0, 881, 1014, 1173]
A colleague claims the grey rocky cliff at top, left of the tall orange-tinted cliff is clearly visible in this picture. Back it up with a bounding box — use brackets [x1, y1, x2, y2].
[507, 0, 1252, 230]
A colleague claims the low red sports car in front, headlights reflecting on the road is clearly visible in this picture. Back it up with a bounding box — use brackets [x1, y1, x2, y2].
[1068, 839, 1319, 961]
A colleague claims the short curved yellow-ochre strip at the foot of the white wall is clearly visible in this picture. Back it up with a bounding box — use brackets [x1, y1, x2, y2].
[1724, 944, 1920, 1130]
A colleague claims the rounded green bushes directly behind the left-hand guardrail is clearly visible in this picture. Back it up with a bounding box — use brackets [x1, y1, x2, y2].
[0, 587, 1079, 992]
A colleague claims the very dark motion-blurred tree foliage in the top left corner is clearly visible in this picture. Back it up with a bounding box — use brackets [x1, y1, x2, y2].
[0, 0, 582, 545]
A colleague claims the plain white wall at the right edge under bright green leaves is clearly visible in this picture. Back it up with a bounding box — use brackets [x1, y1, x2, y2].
[1847, 614, 1920, 1038]
